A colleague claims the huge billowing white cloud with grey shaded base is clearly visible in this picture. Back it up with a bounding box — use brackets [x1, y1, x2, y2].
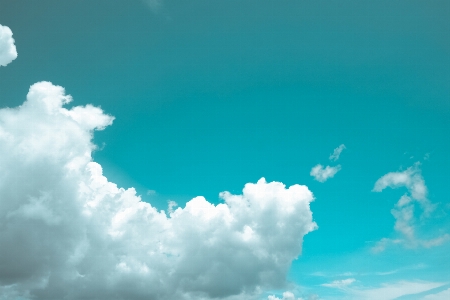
[0, 82, 316, 300]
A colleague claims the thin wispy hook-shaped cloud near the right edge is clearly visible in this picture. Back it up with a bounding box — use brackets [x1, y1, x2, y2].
[372, 163, 450, 252]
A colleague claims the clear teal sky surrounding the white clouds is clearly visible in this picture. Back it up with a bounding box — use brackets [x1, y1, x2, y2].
[0, 0, 450, 299]
